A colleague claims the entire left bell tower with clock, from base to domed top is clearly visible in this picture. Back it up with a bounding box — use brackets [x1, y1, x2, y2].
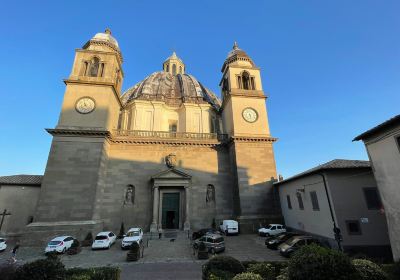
[27, 29, 123, 240]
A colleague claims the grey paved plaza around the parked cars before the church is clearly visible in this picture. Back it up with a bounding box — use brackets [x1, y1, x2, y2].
[0, 233, 285, 279]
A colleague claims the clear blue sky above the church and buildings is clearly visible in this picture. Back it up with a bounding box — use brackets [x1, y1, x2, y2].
[0, 0, 400, 177]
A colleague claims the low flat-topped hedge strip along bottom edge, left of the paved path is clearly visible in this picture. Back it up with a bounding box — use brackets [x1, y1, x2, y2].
[66, 266, 121, 280]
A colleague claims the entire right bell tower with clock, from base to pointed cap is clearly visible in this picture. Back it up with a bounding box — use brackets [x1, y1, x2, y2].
[220, 42, 280, 230]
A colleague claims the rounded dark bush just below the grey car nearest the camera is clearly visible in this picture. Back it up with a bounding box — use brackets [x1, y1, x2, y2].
[202, 256, 244, 279]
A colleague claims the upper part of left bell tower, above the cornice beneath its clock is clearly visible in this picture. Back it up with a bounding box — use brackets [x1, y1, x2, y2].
[57, 29, 123, 131]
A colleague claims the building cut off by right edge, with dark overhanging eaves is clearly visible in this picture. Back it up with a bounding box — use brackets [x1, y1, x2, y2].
[353, 115, 400, 260]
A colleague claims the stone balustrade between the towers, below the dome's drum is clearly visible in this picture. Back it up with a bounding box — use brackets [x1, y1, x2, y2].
[113, 129, 228, 141]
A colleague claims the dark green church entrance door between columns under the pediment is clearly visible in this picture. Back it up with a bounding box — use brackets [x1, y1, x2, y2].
[162, 192, 180, 229]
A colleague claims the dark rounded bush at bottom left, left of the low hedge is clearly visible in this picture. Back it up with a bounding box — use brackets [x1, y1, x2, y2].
[14, 256, 65, 280]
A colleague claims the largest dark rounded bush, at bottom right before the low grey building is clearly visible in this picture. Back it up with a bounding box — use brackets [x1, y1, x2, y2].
[288, 245, 355, 280]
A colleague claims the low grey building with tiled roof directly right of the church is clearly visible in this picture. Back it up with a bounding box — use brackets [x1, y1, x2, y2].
[275, 159, 391, 256]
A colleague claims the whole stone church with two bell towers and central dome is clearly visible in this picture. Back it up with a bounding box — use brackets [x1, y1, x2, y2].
[26, 30, 281, 239]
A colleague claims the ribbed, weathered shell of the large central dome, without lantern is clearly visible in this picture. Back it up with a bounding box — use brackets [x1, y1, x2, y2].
[122, 71, 221, 110]
